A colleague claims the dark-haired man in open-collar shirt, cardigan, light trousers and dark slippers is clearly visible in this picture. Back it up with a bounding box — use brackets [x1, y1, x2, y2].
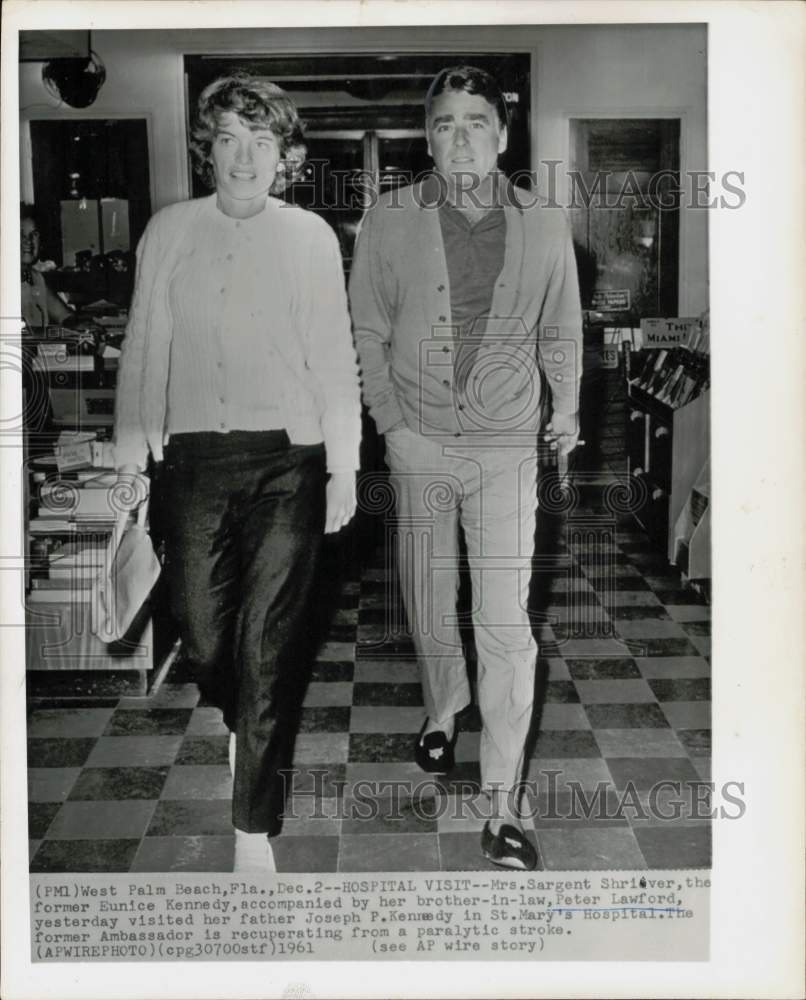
[350, 66, 582, 869]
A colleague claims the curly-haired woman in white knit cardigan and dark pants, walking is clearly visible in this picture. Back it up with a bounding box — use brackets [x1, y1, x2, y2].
[114, 75, 360, 870]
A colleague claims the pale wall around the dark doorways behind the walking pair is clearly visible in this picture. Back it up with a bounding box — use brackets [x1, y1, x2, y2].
[20, 25, 708, 315]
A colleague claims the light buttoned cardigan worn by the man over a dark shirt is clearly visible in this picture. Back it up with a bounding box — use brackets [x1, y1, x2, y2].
[350, 175, 582, 443]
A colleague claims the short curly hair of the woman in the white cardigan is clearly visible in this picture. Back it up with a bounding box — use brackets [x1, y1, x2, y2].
[190, 73, 306, 194]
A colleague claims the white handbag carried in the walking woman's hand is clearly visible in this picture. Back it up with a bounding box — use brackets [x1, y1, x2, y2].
[90, 501, 160, 643]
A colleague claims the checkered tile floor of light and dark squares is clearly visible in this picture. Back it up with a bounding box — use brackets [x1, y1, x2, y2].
[28, 496, 711, 872]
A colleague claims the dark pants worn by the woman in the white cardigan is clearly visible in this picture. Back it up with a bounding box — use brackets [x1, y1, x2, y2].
[157, 431, 326, 833]
